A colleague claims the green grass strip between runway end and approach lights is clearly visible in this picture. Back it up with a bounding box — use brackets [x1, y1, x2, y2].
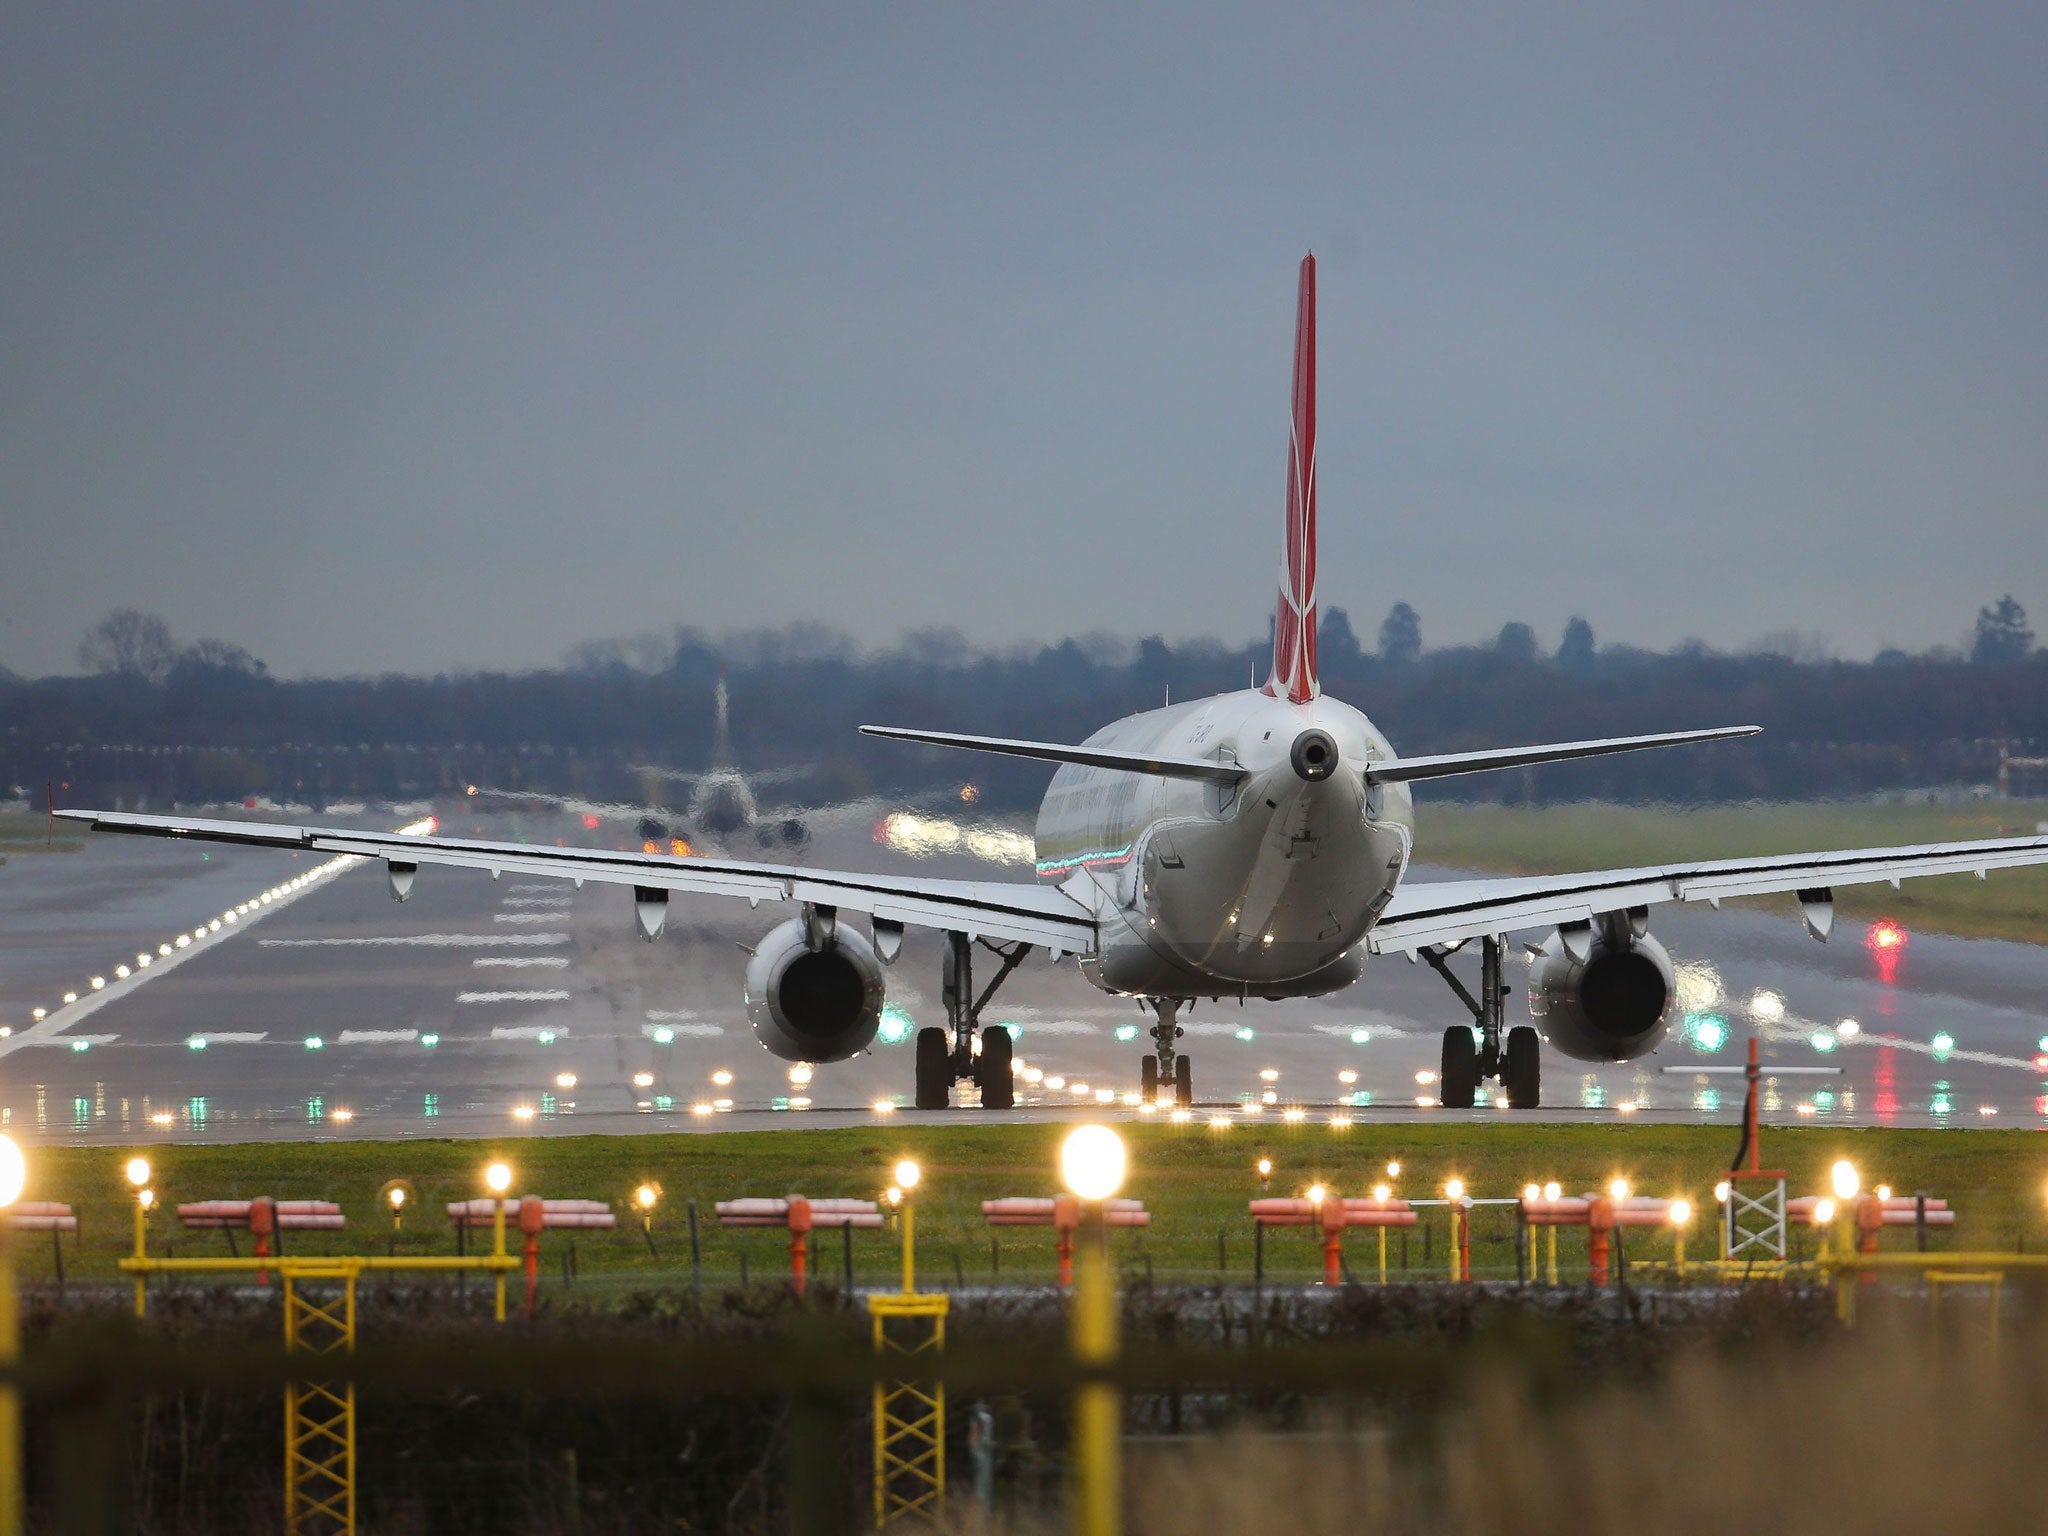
[18, 1122, 2048, 1298]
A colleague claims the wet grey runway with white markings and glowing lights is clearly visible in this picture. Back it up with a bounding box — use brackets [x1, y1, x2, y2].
[0, 815, 2048, 1143]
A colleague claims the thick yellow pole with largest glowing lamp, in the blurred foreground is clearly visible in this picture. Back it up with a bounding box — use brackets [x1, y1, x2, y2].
[1059, 1124, 1126, 1536]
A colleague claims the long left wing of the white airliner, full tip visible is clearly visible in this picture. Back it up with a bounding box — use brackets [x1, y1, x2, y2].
[55, 811, 1096, 954]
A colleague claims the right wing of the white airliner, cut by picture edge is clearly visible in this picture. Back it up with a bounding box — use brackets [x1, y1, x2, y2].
[1370, 838, 2048, 954]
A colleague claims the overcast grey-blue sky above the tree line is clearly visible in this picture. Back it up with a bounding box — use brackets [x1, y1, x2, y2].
[0, 0, 2048, 674]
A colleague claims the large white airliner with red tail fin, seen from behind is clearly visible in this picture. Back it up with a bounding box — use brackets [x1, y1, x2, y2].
[57, 254, 2048, 1110]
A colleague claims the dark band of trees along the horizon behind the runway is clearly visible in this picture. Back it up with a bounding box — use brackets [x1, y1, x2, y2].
[0, 596, 2048, 809]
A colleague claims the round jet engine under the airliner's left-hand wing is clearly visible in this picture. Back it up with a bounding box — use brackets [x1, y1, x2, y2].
[748, 918, 883, 1061]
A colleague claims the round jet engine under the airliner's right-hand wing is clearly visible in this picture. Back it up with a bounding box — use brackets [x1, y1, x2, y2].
[1530, 913, 1677, 1061]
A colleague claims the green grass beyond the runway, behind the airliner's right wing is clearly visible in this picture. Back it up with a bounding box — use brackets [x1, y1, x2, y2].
[1415, 801, 2048, 944]
